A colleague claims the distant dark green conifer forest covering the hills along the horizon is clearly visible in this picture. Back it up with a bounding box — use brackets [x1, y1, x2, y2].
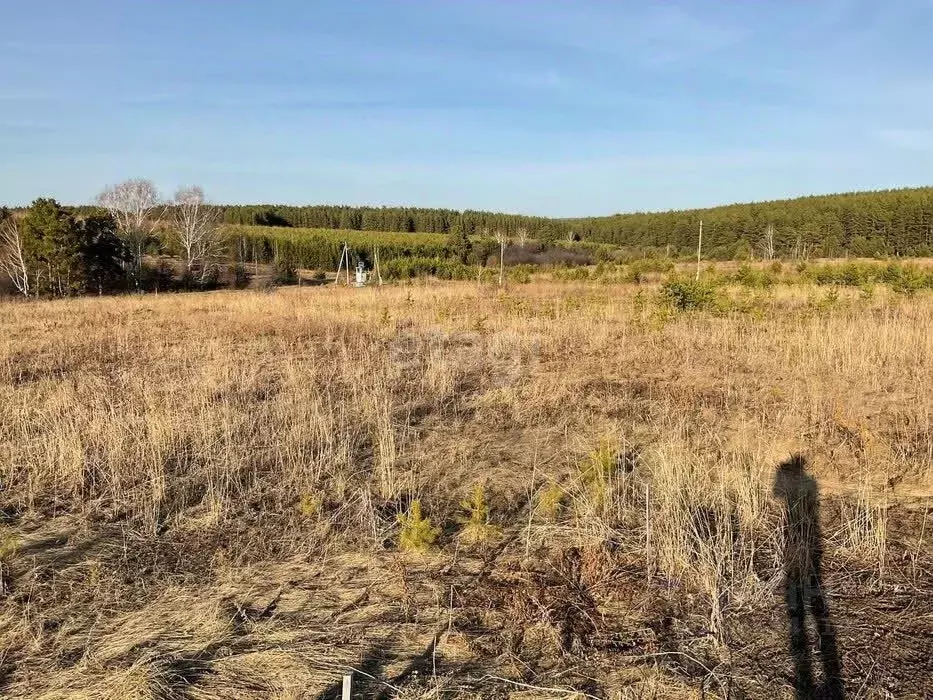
[187, 187, 933, 259]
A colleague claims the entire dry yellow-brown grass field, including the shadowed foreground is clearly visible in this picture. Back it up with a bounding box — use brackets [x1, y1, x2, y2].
[0, 281, 933, 700]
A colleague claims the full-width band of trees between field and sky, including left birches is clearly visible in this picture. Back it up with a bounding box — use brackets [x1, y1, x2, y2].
[0, 179, 933, 296]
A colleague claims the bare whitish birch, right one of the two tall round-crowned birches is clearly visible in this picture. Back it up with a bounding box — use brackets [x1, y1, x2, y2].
[172, 186, 223, 282]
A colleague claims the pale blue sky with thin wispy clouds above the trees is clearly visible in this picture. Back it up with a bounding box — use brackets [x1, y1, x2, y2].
[0, 0, 933, 216]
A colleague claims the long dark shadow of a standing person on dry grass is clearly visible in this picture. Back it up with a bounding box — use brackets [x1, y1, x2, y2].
[774, 455, 844, 700]
